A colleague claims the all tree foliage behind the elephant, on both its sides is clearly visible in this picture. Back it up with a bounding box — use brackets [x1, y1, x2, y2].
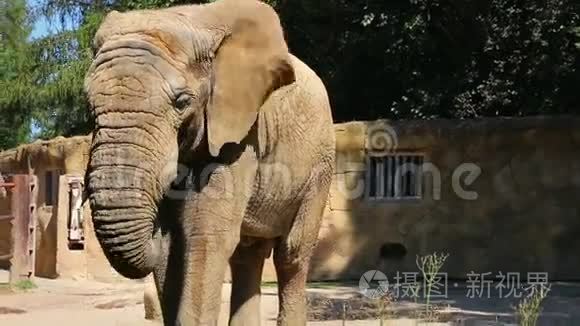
[0, 0, 580, 146]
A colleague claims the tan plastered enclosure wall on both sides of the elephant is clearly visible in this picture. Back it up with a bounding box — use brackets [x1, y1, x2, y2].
[0, 117, 580, 281]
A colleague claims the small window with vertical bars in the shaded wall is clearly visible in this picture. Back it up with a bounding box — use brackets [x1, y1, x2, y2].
[366, 153, 424, 200]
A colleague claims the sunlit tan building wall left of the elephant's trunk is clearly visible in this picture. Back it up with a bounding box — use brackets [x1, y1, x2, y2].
[0, 136, 121, 281]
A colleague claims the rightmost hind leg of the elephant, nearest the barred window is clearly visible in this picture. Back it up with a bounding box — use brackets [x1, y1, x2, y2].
[274, 176, 329, 326]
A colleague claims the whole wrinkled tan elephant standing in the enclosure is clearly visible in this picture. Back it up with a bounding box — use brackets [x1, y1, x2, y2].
[85, 0, 335, 326]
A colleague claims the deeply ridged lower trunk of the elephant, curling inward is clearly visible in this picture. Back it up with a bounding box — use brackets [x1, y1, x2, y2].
[88, 144, 159, 279]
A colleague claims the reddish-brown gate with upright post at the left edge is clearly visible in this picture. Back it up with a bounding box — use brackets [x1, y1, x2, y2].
[0, 175, 37, 285]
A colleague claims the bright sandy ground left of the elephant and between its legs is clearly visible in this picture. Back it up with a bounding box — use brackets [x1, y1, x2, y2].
[0, 279, 357, 326]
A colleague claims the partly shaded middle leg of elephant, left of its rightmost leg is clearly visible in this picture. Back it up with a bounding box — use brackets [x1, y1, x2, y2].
[229, 240, 272, 326]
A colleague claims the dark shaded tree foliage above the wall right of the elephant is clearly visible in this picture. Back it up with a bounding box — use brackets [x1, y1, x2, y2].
[279, 0, 580, 120]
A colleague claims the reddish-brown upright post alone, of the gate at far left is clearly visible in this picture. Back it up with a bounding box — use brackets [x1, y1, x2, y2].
[10, 175, 34, 285]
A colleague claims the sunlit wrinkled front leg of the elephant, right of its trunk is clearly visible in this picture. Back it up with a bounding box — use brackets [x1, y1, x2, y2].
[178, 151, 256, 326]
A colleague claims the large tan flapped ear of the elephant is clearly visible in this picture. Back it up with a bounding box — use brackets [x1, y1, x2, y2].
[206, 1, 295, 157]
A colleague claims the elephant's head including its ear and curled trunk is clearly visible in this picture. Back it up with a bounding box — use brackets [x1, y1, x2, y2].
[85, 0, 295, 278]
